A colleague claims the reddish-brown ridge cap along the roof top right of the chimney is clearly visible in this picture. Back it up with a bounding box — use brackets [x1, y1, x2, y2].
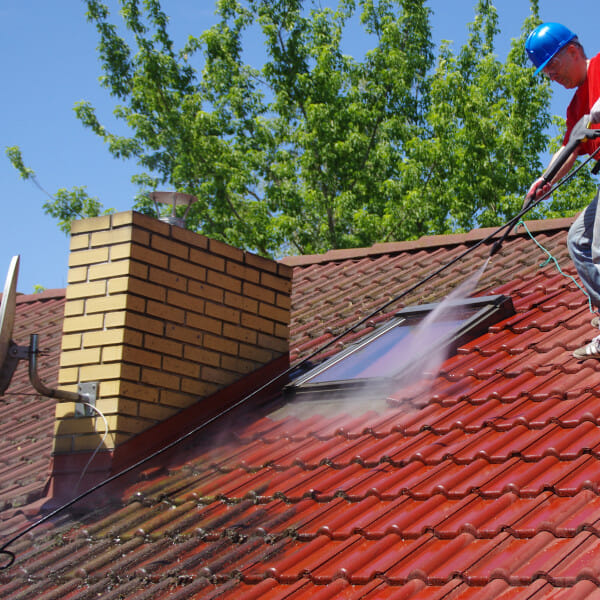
[279, 216, 575, 267]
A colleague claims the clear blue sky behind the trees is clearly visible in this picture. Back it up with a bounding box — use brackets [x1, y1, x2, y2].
[0, 0, 600, 293]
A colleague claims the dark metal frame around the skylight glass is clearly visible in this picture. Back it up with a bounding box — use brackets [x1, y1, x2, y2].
[286, 294, 515, 393]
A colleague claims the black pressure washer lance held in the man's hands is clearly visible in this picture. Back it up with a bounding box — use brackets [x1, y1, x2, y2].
[490, 115, 600, 257]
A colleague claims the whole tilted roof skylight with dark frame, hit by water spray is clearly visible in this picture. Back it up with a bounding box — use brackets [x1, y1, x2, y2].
[292, 296, 514, 388]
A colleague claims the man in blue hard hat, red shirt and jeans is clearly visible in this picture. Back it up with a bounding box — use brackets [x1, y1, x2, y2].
[525, 23, 600, 360]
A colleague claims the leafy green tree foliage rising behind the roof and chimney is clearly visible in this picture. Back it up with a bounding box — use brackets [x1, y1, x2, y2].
[9, 0, 596, 256]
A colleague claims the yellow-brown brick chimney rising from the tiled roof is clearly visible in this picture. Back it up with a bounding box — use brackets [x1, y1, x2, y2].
[54, 212, 291, 492]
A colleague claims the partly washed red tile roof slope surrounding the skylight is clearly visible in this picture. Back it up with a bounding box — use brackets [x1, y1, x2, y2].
[0, 221, 600, 600]
